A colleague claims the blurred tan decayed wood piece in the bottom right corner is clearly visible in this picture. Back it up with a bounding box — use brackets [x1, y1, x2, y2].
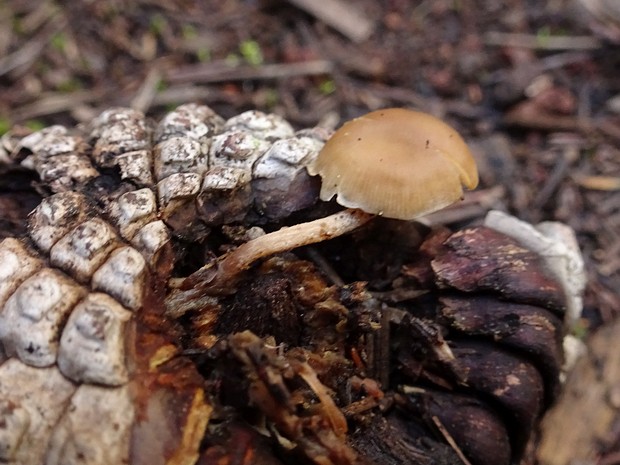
[538, 321, 620, 465]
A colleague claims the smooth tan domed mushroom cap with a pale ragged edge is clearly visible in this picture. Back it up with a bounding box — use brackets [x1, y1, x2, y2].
[308, 108, 478, 220]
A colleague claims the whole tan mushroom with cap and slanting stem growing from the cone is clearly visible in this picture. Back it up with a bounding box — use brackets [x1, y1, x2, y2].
[181, 108, 478, 294]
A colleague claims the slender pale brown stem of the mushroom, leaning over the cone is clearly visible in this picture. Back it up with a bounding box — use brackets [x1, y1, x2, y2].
[181, 208, 375, 294]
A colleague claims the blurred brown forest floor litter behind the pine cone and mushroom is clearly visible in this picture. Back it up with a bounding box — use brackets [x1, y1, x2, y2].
[0, 0, 620, 465]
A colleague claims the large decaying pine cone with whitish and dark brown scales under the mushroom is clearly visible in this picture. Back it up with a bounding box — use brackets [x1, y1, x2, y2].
[0, 104, 565, 465]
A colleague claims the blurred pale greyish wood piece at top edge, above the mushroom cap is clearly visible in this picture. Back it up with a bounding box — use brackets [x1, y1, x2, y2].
[288, 0, 375, 42]
